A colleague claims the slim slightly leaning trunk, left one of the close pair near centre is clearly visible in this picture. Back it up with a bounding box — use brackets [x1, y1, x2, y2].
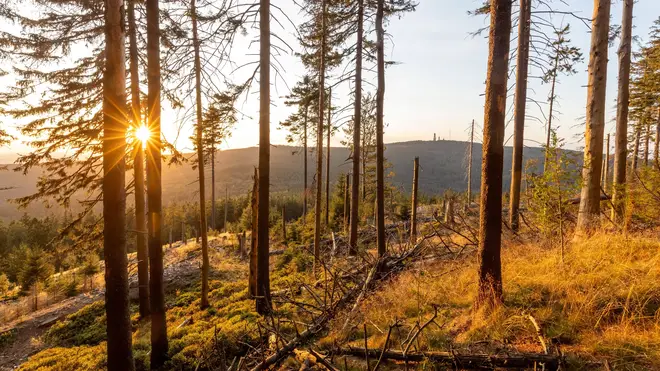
[349, 0, 364, 254]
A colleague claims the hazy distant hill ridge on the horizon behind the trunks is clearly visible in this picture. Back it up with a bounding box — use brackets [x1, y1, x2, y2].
[0, 140, 543, 220]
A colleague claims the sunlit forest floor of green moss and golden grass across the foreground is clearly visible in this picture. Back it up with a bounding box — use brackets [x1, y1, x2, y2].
[5, 226, 660, 370]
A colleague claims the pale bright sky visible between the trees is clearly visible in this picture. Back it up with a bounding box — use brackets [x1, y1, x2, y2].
[0, 0, 660, 163]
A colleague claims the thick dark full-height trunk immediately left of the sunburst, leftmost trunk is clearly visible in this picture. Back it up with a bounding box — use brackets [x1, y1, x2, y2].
[102, 0, 135, 371]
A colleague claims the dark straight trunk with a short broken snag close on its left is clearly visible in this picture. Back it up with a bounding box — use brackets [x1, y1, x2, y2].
[256, 0, 271, 314]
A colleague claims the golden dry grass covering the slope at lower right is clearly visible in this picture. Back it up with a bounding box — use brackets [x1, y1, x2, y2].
[324, 234, 660, 370]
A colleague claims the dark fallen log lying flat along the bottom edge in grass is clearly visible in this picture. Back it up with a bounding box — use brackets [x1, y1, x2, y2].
[332, 347, 561, 370]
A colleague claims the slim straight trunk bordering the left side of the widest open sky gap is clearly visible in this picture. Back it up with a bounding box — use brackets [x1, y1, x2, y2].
[376, 0, 387, 257]
